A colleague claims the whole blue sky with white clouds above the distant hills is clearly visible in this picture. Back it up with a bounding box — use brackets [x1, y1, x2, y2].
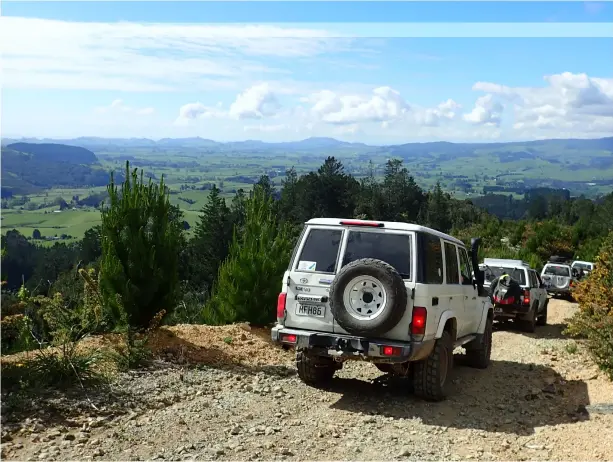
[0, 1, 613, 143]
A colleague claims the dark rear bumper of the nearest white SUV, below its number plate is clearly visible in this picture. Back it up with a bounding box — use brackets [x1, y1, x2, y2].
[271, 325, 436, 363]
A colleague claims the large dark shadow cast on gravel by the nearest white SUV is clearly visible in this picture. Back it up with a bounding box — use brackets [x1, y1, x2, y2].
[330, 357, 590, 436]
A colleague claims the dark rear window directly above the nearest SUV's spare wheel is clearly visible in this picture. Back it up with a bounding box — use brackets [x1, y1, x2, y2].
[343, 231, 411, 279]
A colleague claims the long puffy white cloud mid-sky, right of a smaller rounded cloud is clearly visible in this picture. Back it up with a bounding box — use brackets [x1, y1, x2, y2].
[301, 87, 410, 124]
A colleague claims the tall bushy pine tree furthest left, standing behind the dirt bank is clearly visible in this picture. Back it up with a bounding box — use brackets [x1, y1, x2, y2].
[100, 162, 183, 331]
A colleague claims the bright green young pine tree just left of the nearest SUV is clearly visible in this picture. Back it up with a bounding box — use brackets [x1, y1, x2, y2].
[204, 186, 293, 325]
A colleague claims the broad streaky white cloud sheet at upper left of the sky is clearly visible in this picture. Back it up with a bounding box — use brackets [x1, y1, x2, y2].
[0, 16, 352, 91]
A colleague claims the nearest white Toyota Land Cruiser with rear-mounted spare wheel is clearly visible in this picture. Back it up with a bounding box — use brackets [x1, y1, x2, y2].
[272, 218, 494, 400]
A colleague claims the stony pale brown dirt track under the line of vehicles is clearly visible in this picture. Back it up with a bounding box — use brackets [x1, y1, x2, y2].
[2, 300, 613, 460]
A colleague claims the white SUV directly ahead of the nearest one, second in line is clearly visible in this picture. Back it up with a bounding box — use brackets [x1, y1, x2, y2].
[479, 258, 549, 332]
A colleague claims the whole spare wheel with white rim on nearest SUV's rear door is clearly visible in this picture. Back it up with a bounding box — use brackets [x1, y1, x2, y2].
[330, 258, 407, 336]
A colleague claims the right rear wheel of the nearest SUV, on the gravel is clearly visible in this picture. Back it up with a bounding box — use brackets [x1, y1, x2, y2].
[413, 332, 453, 401]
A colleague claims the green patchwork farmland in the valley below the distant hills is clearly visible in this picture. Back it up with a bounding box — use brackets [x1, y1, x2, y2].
[1, 147, 613, 245]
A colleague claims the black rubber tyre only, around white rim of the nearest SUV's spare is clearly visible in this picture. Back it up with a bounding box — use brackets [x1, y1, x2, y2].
[330, 258, 408, 336]
